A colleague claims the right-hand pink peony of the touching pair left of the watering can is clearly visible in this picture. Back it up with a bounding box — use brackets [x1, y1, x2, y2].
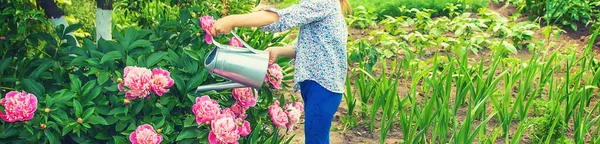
[150, 68, 174, 96]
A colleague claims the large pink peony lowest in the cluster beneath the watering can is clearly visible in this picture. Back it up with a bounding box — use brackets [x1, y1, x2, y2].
[208, 112, 240, 144]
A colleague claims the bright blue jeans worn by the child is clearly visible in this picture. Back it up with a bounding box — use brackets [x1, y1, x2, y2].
[300, 80, 342, 144]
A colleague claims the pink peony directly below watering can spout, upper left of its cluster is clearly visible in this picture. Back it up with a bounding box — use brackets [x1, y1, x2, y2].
[192, 96, 221, 124]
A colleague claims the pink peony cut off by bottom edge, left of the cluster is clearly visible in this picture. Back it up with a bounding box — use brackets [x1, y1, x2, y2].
[129, 124, 162, 144]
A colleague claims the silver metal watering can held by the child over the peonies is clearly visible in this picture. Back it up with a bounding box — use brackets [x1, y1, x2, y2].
[196, 31, 269, 92]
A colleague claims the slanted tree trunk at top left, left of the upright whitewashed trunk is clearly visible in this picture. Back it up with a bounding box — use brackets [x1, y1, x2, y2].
[38, 0, 79, 46]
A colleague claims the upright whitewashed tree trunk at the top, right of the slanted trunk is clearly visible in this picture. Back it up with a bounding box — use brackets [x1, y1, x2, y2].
[96, 0, 113, 41]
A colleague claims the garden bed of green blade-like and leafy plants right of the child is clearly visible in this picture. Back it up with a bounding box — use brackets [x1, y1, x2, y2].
[341, 2, 600, 143]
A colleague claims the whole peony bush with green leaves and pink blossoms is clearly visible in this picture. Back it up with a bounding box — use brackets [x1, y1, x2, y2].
[0, 0, 302, 144]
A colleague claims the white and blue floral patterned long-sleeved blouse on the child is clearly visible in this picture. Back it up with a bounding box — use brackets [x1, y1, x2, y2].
[260, 0, 348, 93]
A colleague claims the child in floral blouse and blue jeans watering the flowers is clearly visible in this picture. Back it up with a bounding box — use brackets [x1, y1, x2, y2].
[210, 0, 350, 144]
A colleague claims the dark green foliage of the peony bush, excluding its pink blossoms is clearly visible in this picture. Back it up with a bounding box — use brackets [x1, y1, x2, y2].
[0, 1, 294, 143]
